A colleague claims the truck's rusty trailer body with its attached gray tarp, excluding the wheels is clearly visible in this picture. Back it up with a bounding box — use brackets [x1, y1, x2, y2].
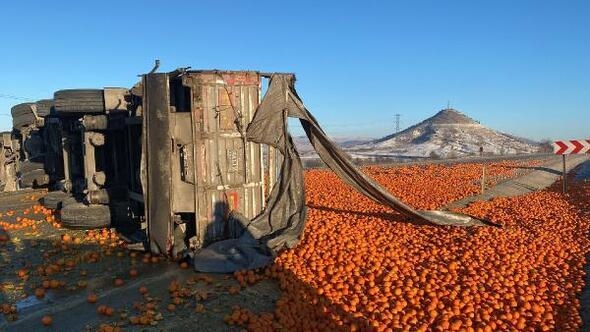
[130, 70, 480, 272]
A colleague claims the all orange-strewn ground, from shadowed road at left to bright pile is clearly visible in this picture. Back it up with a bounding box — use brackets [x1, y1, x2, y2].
[0, 160, 590, 331]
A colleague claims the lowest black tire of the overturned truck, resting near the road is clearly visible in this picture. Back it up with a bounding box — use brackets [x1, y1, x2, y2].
[61, 202, 111, 229]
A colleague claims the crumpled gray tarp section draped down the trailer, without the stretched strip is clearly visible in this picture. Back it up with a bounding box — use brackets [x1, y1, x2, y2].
[194, 75, 306, 272]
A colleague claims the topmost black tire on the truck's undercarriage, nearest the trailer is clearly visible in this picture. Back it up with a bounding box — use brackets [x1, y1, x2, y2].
[53, 89, 105, 114]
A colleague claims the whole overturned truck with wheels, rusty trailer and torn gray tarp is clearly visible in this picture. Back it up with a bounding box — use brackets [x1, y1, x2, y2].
[6, 69, 484, 272]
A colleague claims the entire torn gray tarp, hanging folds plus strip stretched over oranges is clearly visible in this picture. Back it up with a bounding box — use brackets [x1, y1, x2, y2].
[195, 74, 480, 272]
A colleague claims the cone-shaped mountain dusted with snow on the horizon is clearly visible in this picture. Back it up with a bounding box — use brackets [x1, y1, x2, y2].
[345, 108, 539, 158]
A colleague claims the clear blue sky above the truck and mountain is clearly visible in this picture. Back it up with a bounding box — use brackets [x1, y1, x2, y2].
[0, 0, 590, 139]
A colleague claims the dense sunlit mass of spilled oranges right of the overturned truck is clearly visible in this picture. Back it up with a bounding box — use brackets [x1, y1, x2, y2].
[234, 160, 590, 331]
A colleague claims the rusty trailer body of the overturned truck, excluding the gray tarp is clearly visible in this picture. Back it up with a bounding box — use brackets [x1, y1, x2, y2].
[128, 70, 281, 256]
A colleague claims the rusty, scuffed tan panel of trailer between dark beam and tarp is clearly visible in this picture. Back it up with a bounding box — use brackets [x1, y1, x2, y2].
[191, 72, 264, 245]
